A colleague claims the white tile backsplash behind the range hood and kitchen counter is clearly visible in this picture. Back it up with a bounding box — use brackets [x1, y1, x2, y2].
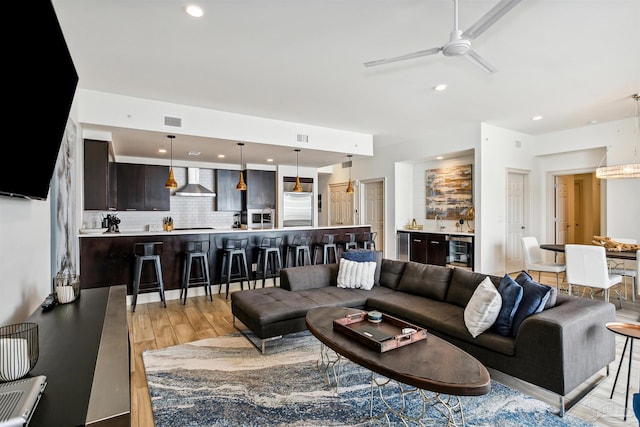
[83, 167, 234, 231]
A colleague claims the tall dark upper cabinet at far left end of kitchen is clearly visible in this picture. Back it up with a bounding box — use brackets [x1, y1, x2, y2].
[84, 139, 116, 211]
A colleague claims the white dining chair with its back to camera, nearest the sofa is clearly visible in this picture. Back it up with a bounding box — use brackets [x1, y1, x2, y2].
[564, 244, 622, 308]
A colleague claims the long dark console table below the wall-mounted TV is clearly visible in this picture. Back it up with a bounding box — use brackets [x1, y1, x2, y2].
[27, 285, 131, 427]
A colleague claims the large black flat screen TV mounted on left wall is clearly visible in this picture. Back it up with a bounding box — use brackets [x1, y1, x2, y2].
[0, 0, 78, 200]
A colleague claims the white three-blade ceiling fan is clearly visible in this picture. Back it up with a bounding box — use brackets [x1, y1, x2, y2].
[364, 0, 522, 73]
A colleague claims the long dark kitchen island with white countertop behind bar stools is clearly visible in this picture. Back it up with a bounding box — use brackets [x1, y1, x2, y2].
[80, 225, 371, 295]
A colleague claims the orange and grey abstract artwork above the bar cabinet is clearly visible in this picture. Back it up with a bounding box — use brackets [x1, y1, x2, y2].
[425, 164, 473, 220]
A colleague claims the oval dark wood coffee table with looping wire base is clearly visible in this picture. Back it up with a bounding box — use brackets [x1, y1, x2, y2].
[306, 307, 491, 425]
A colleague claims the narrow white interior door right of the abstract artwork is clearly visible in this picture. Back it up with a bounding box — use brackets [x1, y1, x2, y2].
[505, 171, 528, 273]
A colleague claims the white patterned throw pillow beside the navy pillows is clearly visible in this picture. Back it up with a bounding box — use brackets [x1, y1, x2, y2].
[464, 277, 502, 338]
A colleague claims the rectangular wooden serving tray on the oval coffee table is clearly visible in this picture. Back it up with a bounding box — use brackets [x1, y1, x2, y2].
[333, 312, 427, 353]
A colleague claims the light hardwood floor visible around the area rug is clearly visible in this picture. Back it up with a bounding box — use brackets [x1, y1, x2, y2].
[128, 273, 640, 427]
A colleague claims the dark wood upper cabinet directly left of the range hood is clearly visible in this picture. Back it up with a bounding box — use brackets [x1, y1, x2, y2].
[117, 163, 170, 211]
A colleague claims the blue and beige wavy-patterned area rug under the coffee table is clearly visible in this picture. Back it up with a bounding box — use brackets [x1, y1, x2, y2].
[142, 332, 591, 427]
